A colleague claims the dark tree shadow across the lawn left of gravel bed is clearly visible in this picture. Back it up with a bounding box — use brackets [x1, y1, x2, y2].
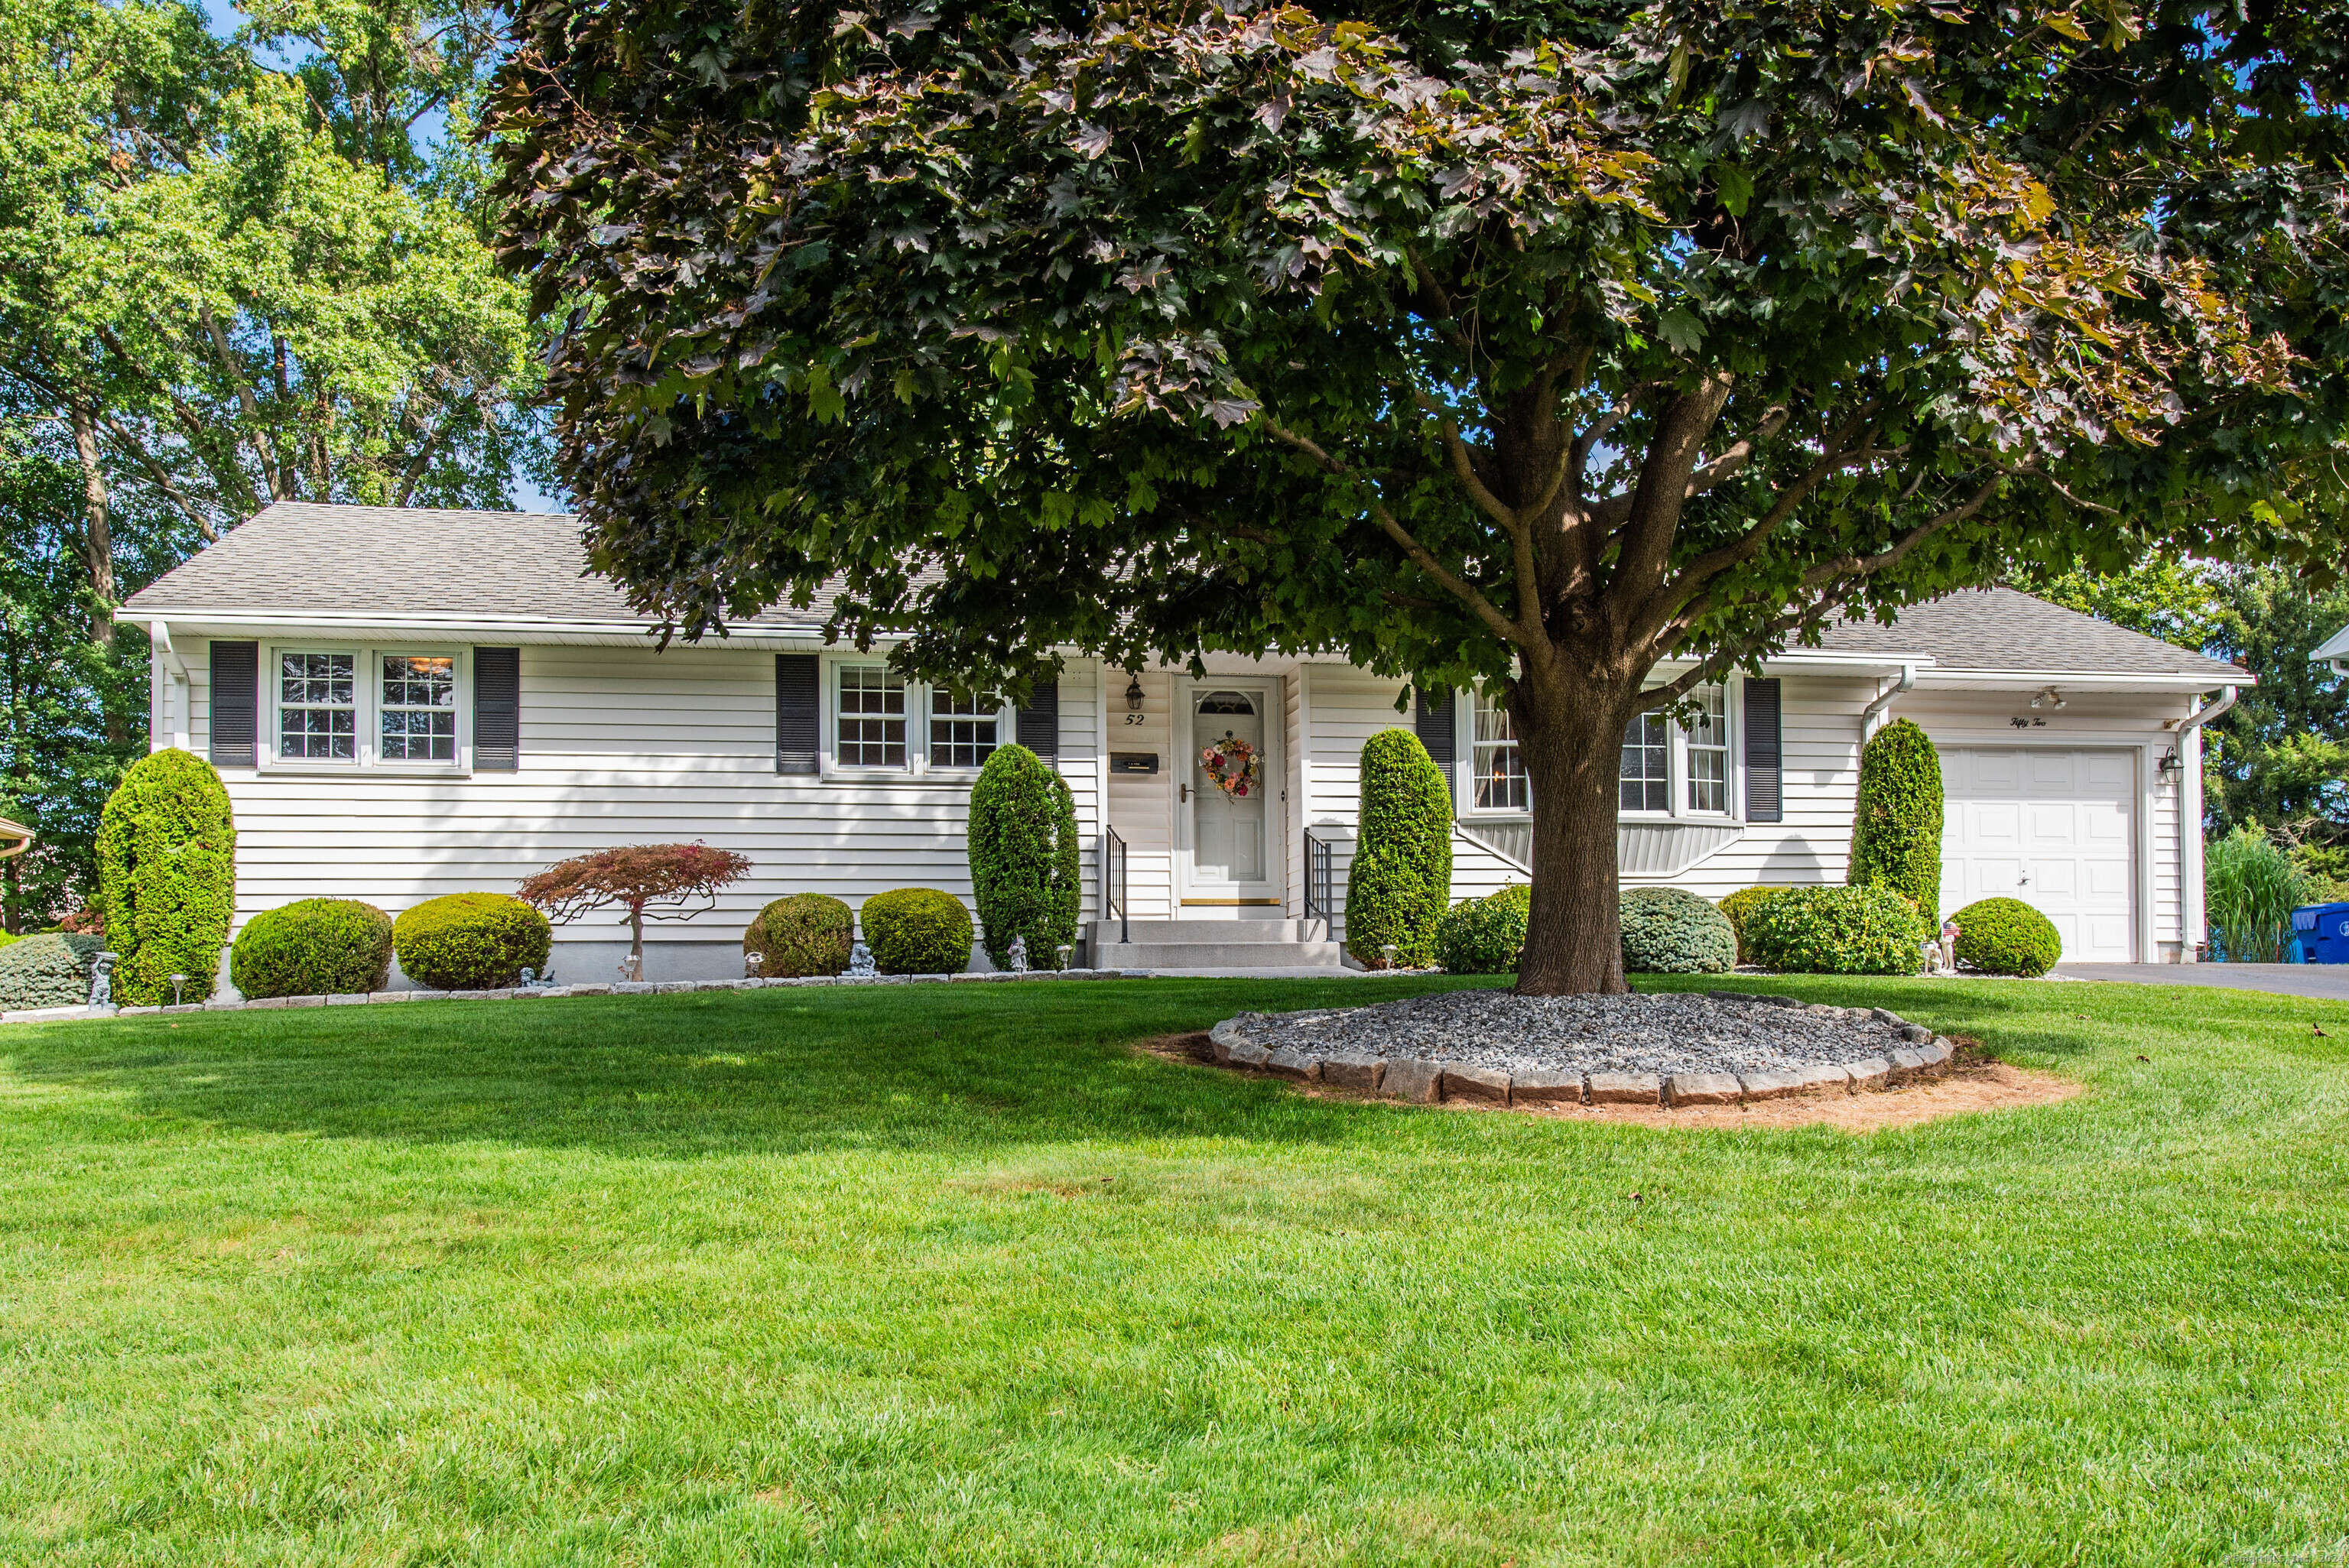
[0, 981, 1503, 1155]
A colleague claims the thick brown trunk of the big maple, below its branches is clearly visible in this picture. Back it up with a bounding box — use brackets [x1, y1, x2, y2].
[1510, 680, 1639, 995]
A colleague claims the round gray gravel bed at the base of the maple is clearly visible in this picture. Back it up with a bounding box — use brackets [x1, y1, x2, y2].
[1226, 991, 1931, 1075]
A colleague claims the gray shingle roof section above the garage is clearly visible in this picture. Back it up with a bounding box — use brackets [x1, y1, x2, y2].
[1823, 587, 2246, 680]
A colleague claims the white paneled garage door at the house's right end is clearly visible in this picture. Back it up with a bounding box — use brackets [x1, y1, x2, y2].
[1940, 746, 2138, 963]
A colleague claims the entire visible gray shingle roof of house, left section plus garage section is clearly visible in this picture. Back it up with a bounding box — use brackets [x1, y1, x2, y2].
[125, 500, 2236, 683]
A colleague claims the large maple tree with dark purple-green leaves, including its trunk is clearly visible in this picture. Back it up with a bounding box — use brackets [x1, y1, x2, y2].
[491, 0, 2344, 993]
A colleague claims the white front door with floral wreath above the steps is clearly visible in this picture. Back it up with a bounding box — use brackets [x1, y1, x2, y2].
[1174, 683, 1280, 908]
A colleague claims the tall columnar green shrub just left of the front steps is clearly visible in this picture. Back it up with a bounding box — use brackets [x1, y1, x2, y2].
[970, 746, 1085, 969]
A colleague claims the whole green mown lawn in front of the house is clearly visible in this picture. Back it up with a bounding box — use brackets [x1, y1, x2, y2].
[0, 981, 2349, 1563]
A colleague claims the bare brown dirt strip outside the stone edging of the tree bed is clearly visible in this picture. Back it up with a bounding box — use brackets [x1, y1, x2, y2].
[1135, 1031, 2088, 1134]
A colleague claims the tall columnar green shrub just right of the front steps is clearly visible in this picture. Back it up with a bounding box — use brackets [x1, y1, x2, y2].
[1346, 730, 1451, 969]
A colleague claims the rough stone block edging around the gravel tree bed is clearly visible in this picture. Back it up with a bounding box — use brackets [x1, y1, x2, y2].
[1207, 991, 1957, 1110]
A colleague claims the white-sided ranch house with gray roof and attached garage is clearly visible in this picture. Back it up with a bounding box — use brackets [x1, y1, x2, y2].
[122, 502, 2250, 983]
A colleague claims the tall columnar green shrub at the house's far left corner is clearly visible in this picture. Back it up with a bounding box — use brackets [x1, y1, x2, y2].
[99, 748, 237, 1007]
